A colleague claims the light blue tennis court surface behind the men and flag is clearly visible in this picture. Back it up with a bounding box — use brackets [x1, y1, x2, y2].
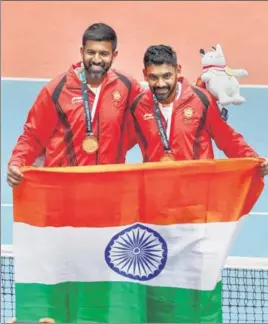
[1, 79, 268, 257]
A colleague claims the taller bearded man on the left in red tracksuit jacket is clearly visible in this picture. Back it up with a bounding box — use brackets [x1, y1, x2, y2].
[7, 23, 142, 187]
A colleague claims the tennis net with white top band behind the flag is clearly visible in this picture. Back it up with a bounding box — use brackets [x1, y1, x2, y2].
[1, 245, 268, 323]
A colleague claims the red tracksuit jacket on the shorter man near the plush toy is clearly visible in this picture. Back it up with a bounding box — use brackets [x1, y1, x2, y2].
[131, 78, 258, 162]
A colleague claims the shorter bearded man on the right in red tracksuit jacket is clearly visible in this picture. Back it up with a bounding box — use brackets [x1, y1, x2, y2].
[131, 45, 268, 175]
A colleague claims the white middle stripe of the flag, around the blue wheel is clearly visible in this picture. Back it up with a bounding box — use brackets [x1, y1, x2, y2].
[14, 220, 242, 290]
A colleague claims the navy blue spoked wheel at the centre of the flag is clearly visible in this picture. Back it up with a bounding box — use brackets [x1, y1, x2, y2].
[105, 224, 168, 281]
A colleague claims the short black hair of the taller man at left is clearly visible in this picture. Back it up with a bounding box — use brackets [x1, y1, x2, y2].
[82, 23, 117, 51]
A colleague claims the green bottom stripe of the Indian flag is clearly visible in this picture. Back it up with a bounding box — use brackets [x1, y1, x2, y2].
[16, 282, 222, 323]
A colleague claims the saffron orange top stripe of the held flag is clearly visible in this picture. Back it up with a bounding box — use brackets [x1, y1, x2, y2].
[14, 159, 263, 227]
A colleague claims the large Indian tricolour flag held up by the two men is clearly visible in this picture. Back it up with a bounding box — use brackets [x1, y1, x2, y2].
[14, 158, 263, 323]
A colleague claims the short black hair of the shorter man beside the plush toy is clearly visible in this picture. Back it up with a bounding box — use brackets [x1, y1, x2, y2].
[143, 45, 177, 67]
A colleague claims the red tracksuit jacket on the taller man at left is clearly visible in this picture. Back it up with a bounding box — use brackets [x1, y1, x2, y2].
[9, 64, 142, 167]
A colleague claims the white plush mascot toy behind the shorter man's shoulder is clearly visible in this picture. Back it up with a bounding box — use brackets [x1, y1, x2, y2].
[200, 44, 248, 107]
